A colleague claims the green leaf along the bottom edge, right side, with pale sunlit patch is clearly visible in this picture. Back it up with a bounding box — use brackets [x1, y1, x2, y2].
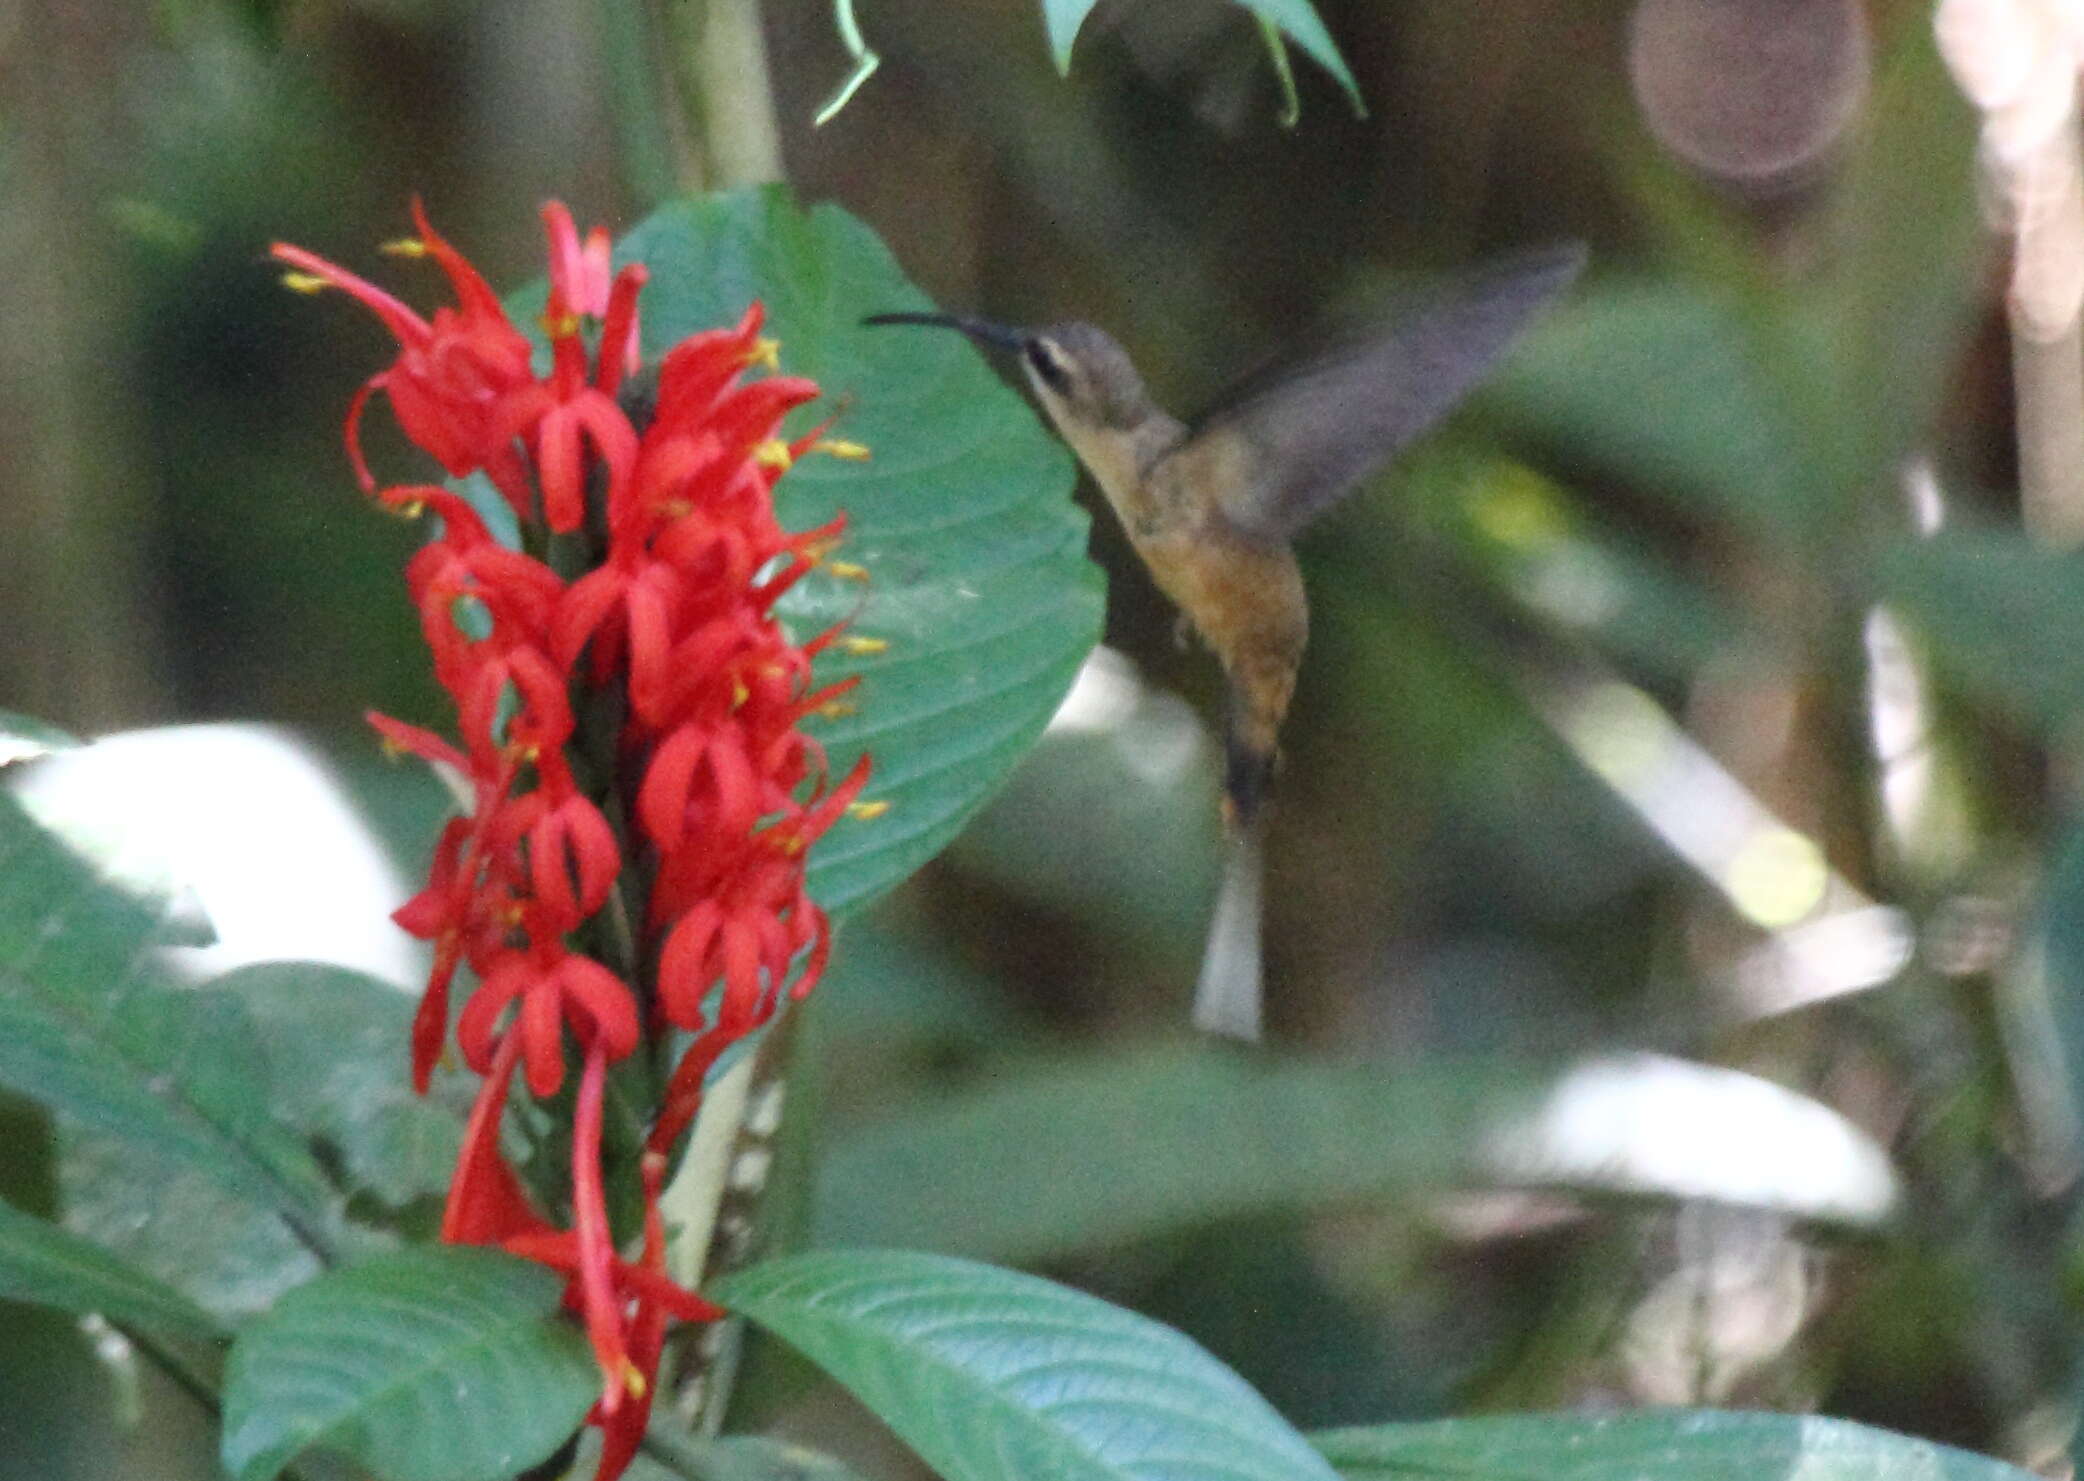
[1311, 1410, 2030, 1481]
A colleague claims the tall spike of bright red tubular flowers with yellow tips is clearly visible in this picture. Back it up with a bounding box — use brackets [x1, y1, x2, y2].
[273, 202, 867, 1481]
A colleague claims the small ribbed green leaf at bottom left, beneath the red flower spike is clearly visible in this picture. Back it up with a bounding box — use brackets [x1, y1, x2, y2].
[221, 1246, 600, 1481]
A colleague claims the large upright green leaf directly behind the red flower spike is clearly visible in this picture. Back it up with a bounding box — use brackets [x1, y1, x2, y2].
[621, 187, 1105, 908]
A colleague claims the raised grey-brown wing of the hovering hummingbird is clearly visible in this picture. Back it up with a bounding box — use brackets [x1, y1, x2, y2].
[1169, 242, 1586, 539]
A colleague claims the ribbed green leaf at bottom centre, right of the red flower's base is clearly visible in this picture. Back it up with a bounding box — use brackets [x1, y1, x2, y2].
[713, 1250, 1330, 1481]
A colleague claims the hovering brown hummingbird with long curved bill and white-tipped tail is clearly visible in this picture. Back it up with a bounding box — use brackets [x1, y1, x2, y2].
[863, 242, 1586, 1039]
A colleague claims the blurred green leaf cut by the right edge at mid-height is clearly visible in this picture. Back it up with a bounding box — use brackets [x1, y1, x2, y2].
[1880, 529, 2084, 731]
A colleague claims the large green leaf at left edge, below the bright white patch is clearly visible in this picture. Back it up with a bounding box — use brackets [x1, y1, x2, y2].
[0, 796, 331, 1244]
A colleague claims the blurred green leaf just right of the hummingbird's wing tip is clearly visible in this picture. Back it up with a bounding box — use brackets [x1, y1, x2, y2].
[1486, 281, 1813, 537]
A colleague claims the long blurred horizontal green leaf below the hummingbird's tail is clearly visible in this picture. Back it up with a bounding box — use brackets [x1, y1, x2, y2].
[817, 1050, 1540, 1260]
